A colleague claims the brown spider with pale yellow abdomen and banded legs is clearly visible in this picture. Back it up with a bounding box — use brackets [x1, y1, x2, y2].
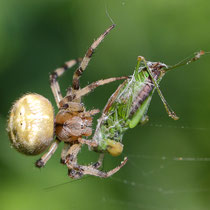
[7, 25, 127, 178]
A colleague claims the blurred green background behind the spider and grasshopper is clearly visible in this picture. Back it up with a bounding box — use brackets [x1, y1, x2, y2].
[0, 0, 210, 210]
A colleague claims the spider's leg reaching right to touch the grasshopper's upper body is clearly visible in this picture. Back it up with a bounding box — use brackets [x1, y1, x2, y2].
[75, 76, 128, 99]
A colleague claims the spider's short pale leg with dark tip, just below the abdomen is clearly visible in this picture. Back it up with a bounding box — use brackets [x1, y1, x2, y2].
[35, 139, 60, 168]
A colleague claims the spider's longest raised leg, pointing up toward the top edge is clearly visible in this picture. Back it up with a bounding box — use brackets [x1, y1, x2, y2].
[72, 25, 115, 90]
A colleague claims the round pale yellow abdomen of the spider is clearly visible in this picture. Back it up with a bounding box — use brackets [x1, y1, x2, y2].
[7, 93, 54, 155]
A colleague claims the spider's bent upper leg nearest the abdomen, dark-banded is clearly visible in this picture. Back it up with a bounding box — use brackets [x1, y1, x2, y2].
[50, 59, 80, 107]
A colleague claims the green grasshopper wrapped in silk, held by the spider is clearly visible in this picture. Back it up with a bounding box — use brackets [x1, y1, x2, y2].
[93, 51, 205, 156]
